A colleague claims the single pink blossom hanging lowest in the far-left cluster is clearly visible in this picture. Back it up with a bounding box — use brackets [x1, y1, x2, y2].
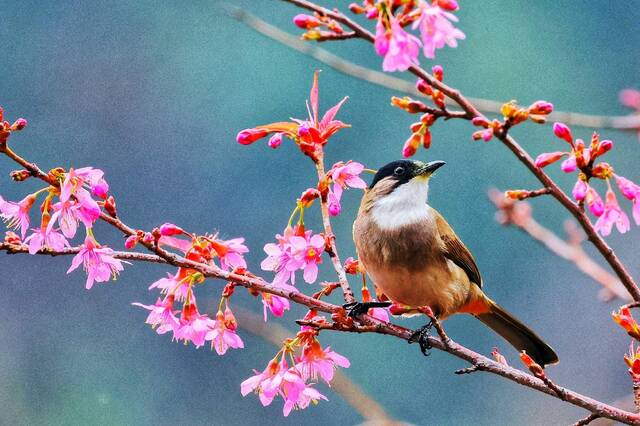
[67, 236, 127, 290]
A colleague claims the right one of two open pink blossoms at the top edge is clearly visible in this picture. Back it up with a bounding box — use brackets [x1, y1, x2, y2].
[413, 0, 465, 59]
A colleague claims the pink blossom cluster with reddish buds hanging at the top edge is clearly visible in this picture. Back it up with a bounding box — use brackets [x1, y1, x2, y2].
[349, 0, 465, 71]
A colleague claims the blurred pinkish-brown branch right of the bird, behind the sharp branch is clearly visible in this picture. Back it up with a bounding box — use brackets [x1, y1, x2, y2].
[489, 189, 631, 300]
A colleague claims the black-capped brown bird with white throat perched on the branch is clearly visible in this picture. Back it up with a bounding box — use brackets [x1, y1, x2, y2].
[353, 160, 558, 367]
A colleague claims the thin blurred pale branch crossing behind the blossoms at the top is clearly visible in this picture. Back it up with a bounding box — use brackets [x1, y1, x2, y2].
[226, 6, 640, 130]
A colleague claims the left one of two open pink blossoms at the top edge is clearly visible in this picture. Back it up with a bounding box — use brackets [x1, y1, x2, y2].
[376, 16, 420, 72]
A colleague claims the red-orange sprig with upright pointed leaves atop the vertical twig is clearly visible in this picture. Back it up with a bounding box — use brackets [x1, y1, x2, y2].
[236, 71, 350, 163]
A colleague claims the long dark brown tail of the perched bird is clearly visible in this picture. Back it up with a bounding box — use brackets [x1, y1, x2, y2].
[474, 298, 558, 367]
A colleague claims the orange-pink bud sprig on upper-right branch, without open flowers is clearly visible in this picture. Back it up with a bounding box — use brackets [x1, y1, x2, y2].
[471, 101, 553, 142]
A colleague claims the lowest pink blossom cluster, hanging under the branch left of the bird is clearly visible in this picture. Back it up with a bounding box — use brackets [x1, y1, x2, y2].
[240, 320, 350, 416]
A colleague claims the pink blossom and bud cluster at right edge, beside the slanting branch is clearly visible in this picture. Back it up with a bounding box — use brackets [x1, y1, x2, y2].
[535, 123, 640, 236]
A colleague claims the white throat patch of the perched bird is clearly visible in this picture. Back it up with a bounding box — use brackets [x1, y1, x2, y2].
[371, 178, 431, 230]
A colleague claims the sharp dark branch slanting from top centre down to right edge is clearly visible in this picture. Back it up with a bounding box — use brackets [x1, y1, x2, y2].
[283, 0, 640, 301]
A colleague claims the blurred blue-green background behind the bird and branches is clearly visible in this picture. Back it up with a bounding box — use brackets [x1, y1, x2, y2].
[0, 0, 640, 425]
